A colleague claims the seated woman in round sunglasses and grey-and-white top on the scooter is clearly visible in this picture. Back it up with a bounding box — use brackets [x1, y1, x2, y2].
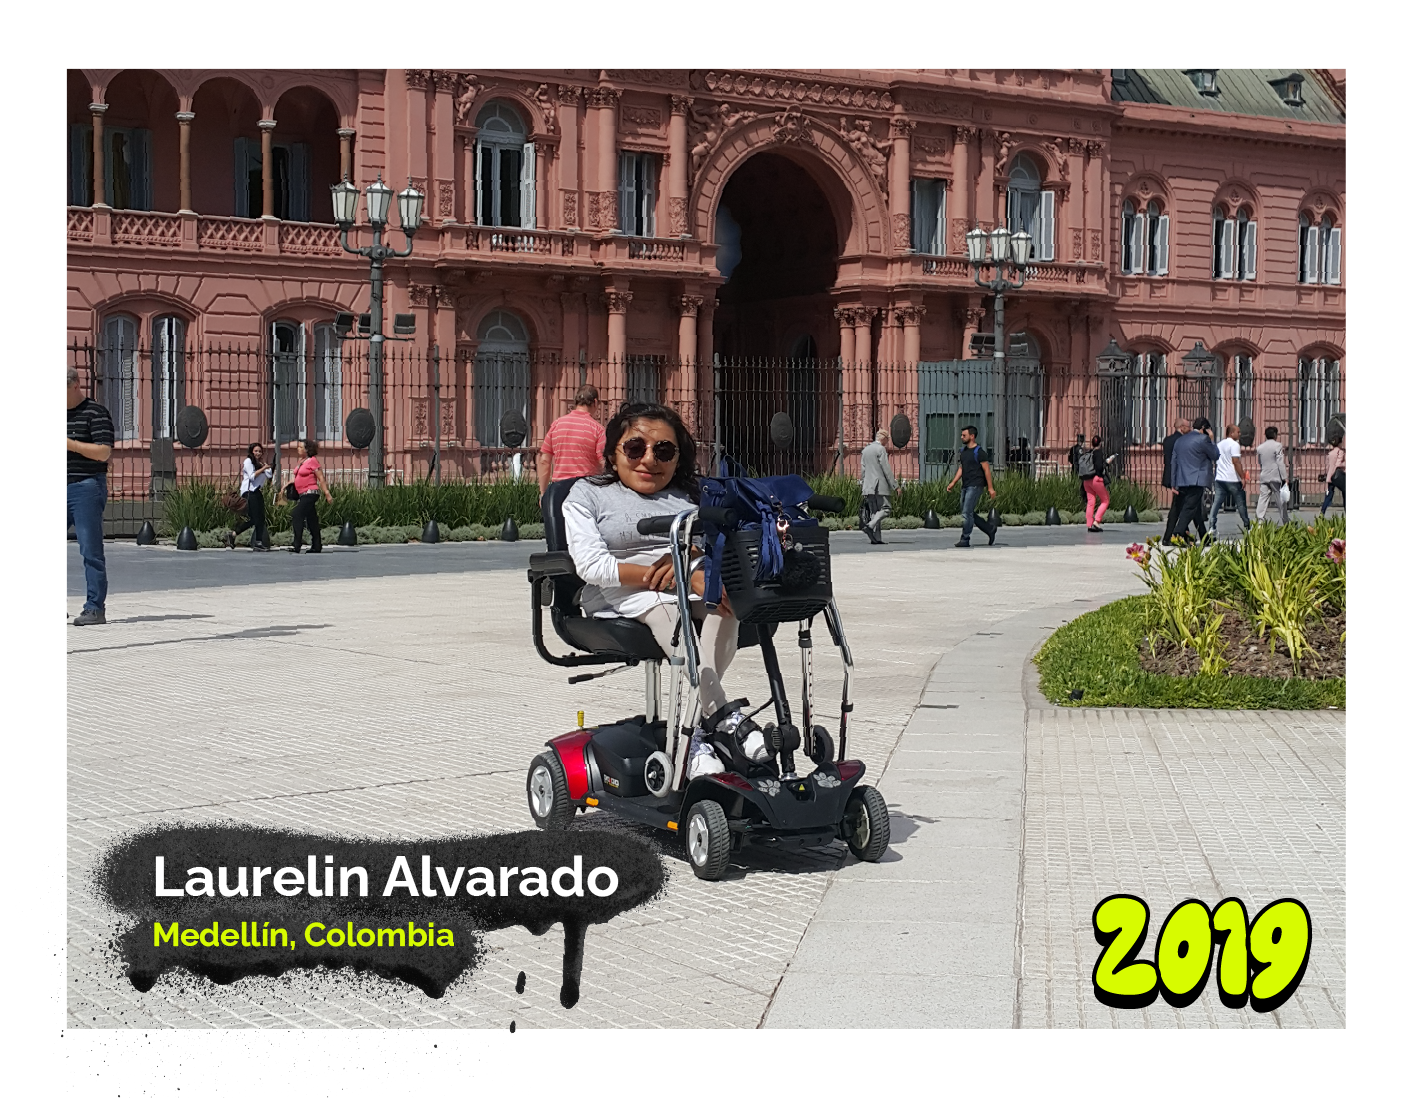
[564, 404, 769, 779]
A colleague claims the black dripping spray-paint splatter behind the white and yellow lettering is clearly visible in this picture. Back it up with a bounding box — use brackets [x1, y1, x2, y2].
[96, 827, 664, 1008]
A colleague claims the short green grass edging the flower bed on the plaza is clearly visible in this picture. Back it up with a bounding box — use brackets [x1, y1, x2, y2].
[1036, 595, 1345, 709]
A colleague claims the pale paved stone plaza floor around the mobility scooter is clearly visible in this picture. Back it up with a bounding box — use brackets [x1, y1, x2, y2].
[66, 526, 1345, 1027]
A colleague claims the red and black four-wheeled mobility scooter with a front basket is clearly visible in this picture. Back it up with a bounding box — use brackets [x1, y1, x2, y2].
[526, 478, 889, 880]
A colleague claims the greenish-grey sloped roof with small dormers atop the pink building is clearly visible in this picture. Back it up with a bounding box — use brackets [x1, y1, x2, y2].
[1113, 69, 1344, 124]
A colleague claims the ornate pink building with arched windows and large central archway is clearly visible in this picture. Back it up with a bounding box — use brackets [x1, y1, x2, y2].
[68, 69, 1345, 499]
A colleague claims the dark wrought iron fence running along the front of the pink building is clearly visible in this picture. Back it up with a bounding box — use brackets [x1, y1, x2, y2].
[69, 339, 1344, 500]
